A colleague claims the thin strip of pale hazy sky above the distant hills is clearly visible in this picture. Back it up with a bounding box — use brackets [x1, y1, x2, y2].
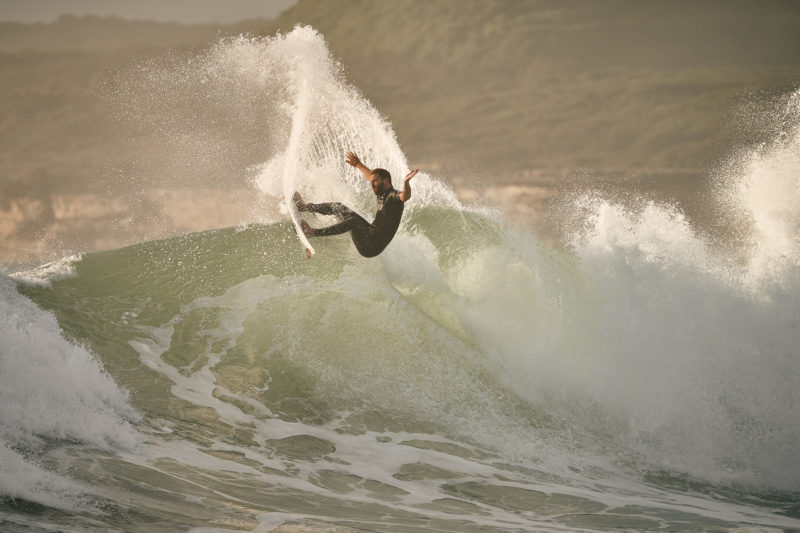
[0, 0, 296, 23]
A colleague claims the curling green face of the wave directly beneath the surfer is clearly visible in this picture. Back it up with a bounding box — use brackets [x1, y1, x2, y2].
[22, 208, 568, 438]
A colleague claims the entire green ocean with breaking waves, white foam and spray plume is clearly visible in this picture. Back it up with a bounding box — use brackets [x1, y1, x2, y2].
[0, 27, 800, 533]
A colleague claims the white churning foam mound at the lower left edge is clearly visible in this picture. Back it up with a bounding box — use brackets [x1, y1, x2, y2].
[0, 275, 139, 507]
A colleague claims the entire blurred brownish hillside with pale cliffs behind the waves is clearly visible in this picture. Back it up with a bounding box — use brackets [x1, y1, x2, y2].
[0, 0, 800, 261]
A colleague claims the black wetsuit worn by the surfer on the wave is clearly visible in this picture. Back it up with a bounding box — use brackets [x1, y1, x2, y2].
[305, 189, 404, 257]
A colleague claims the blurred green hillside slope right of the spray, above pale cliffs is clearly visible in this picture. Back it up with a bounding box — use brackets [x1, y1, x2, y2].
[262, 0, 800, 170]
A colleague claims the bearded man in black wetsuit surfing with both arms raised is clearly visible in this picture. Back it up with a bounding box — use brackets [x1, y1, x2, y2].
[294, 152, 419, 257]
